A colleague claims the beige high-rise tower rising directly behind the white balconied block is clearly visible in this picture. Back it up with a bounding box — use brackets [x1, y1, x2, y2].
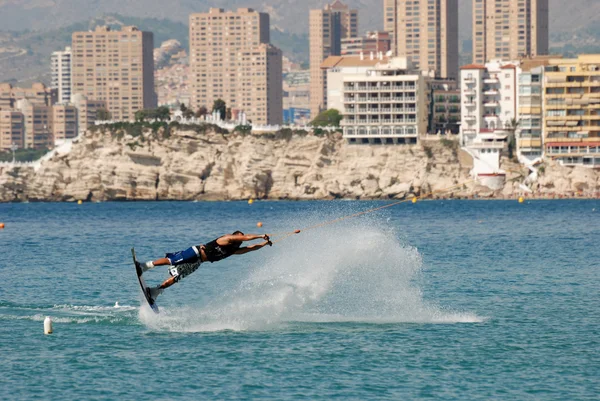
[383, 0, 458, 79]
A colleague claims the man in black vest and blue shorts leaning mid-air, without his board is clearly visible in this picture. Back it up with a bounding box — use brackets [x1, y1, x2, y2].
[135, 231, 273, 304]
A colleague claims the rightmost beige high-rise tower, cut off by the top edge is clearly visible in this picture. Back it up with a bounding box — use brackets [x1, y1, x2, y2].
[473, 0, 548, 64]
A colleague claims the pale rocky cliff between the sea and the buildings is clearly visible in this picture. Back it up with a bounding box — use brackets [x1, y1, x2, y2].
[0, 127, 600, 202]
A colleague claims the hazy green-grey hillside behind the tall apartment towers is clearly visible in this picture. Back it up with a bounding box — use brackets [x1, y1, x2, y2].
[0, 0, 600, 84]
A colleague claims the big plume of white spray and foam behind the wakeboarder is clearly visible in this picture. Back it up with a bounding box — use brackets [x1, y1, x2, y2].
[140, 219, 483, 332]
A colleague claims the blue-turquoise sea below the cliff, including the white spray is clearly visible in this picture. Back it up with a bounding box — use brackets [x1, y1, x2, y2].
[0, 201, 600, 400]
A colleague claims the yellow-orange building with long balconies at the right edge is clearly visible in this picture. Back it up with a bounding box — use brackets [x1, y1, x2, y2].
[543, 54, 600, 168]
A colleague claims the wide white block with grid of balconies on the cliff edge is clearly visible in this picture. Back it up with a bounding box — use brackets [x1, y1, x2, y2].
[323, 57, 428, 144]
